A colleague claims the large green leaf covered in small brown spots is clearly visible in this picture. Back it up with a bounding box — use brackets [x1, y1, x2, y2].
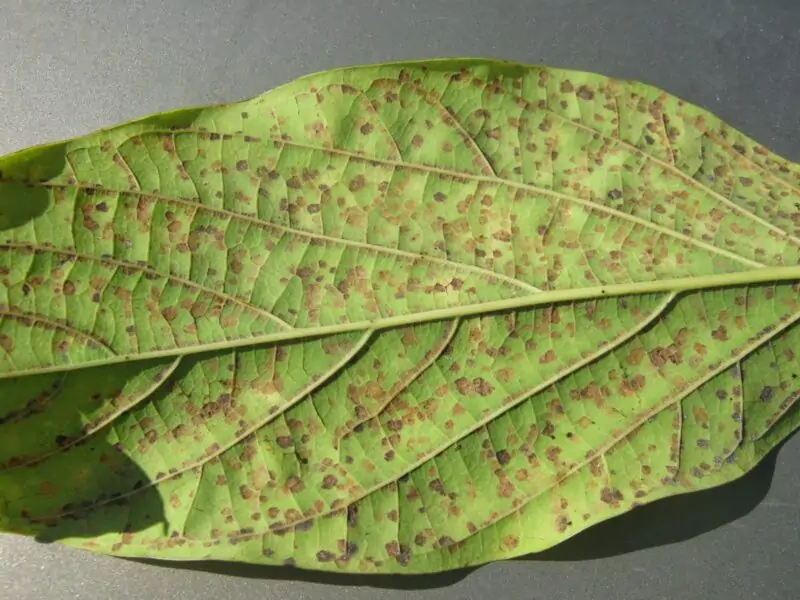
[0, 60, 800, 573]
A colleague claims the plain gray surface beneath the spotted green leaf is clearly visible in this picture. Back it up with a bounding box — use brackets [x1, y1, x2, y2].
[0, 0, 800, 600]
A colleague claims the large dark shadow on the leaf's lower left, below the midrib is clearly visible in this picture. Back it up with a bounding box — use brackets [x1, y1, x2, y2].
[0, 367, 166, 551]
